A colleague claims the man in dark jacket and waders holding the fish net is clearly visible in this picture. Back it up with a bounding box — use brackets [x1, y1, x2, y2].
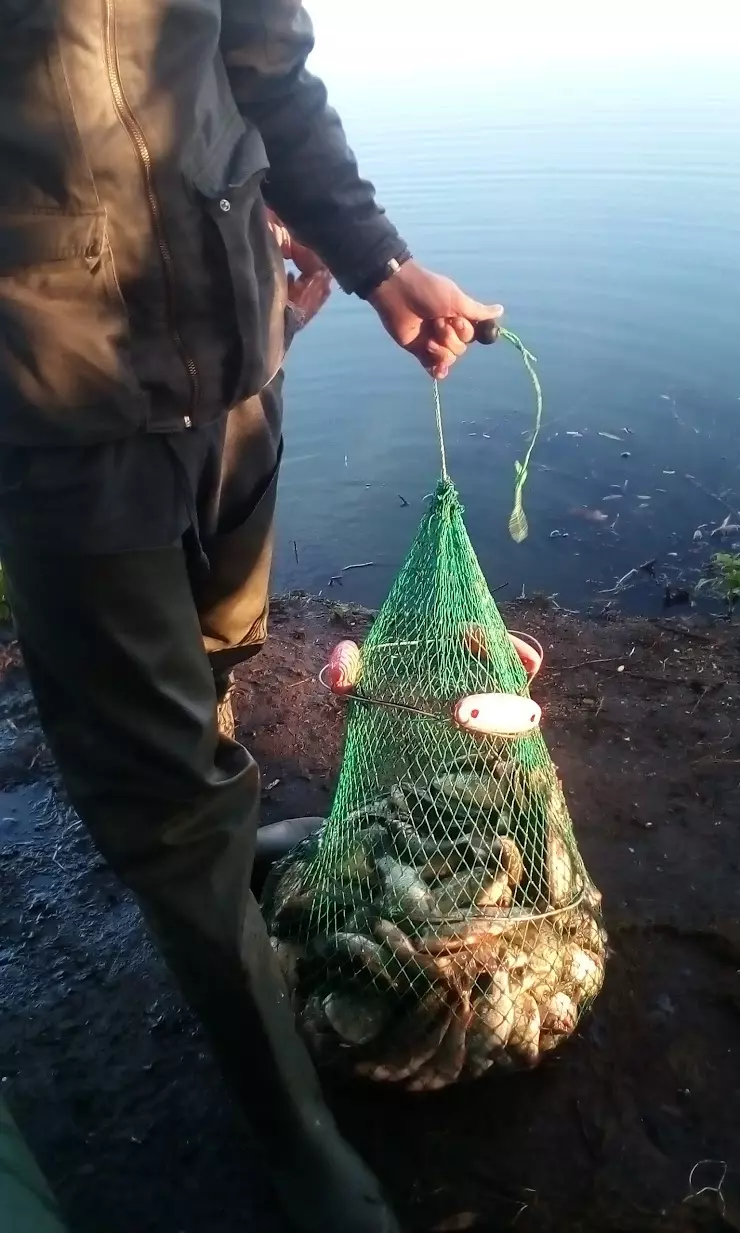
[0, 0, 500, 1233]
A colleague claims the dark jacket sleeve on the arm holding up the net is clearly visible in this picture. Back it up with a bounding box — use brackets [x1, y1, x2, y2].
[221, 0, 406, 292]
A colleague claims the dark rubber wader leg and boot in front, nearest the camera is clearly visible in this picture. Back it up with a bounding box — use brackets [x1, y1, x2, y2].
[4, 545, 393, 1233]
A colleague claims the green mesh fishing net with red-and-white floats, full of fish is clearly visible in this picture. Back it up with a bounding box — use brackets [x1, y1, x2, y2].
[264, 362, 606, 1091]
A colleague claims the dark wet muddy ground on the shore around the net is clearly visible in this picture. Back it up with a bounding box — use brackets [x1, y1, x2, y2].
[0, 597, 740, 1233]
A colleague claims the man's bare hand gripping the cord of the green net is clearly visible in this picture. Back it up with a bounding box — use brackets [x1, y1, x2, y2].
[370, 261, 503, 381]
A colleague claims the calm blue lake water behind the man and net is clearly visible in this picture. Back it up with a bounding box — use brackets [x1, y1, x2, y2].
[274, 64, 740, 612]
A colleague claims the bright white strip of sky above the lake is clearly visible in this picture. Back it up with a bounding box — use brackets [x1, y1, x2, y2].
[305, 0, 740, 80]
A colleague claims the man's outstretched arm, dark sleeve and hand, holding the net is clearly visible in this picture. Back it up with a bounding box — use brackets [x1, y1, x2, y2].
[221, 0, 503, 379]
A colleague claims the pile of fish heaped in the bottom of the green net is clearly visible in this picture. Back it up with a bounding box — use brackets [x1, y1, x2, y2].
[263, 758, 607, 1091]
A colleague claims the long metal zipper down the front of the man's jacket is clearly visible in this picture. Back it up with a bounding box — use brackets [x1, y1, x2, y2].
[104, 0, 200, 428]
